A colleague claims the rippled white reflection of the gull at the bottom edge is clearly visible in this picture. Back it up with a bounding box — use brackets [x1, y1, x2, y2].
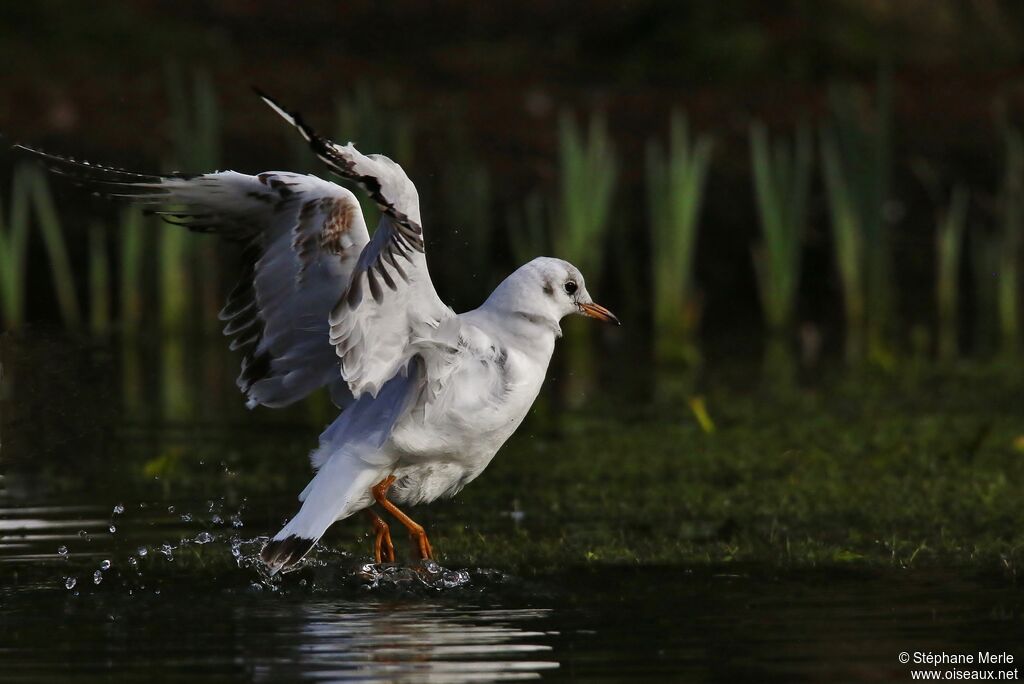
[254, 602, 558, 682]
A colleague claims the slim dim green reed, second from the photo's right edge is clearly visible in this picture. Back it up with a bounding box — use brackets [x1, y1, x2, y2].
[935, 184, 970, 361]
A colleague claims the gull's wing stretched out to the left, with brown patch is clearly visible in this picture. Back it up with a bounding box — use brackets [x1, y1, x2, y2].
[17, 147, 370, 408]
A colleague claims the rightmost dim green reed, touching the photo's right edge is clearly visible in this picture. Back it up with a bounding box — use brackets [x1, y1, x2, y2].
[995, 126, 1024, 356]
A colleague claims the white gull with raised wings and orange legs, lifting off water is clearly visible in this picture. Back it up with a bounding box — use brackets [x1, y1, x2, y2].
[22, 91, 618, 573]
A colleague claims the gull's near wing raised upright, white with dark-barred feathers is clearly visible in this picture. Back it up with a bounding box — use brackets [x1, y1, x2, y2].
[260, 93, 458, 397]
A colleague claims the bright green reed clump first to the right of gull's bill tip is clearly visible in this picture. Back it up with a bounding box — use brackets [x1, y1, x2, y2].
[646, 113, 714, 361]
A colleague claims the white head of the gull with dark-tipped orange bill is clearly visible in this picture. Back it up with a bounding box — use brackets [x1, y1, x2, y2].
[487, 257, 620, 327]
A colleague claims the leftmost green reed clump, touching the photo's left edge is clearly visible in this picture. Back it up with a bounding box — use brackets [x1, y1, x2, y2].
[0, 164, 32, 330]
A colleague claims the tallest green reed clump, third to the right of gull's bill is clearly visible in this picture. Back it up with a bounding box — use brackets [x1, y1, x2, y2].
[821, 70, 893, 365]
